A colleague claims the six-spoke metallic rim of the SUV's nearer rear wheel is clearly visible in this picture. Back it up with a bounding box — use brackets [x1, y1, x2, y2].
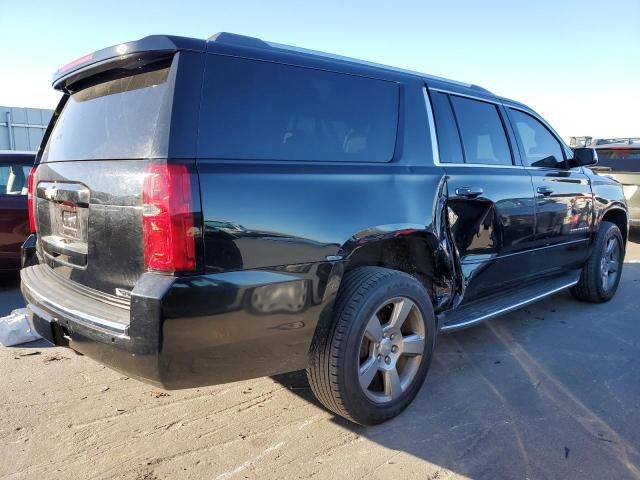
[358, 297, 425, 403]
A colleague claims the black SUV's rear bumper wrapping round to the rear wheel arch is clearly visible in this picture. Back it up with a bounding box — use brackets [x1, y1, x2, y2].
[21, 262, 342, 389]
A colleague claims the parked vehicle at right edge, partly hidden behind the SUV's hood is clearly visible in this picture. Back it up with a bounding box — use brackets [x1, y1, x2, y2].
[592, 138, 640, 227]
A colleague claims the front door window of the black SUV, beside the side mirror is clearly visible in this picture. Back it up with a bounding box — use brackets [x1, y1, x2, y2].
[511, 109, 564, 168]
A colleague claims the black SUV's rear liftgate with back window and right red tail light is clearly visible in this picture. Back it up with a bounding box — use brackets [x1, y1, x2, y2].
[33, 44, 200, 303]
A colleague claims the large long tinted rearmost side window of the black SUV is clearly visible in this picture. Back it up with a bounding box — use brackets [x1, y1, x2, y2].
[198, 55, 399, 162]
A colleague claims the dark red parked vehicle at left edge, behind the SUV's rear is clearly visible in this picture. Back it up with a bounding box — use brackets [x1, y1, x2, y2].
[0, 150, 35, 273]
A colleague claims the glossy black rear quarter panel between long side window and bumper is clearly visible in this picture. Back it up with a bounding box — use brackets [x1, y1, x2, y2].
[197, 160, 443, 272]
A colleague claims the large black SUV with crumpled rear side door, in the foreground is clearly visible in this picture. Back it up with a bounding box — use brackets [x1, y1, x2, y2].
[22, 33, 627, 424]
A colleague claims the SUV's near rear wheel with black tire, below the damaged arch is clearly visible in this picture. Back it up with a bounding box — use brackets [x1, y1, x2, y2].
[307, 267, 436, 425]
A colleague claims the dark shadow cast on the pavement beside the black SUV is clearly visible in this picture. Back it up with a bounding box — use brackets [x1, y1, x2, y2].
[274, 264, 640, 478]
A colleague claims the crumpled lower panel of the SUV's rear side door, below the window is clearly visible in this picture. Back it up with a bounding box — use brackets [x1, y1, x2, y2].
[445, 165, 535, 302]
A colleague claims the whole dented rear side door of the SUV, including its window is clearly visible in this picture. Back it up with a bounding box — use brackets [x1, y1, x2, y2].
[430, 89, 535, 301]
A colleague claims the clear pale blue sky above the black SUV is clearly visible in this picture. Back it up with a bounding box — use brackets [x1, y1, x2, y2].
[0, 0, 640, 138]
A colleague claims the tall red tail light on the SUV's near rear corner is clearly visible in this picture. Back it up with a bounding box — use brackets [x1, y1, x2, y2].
[142, 164, 198, 273]
